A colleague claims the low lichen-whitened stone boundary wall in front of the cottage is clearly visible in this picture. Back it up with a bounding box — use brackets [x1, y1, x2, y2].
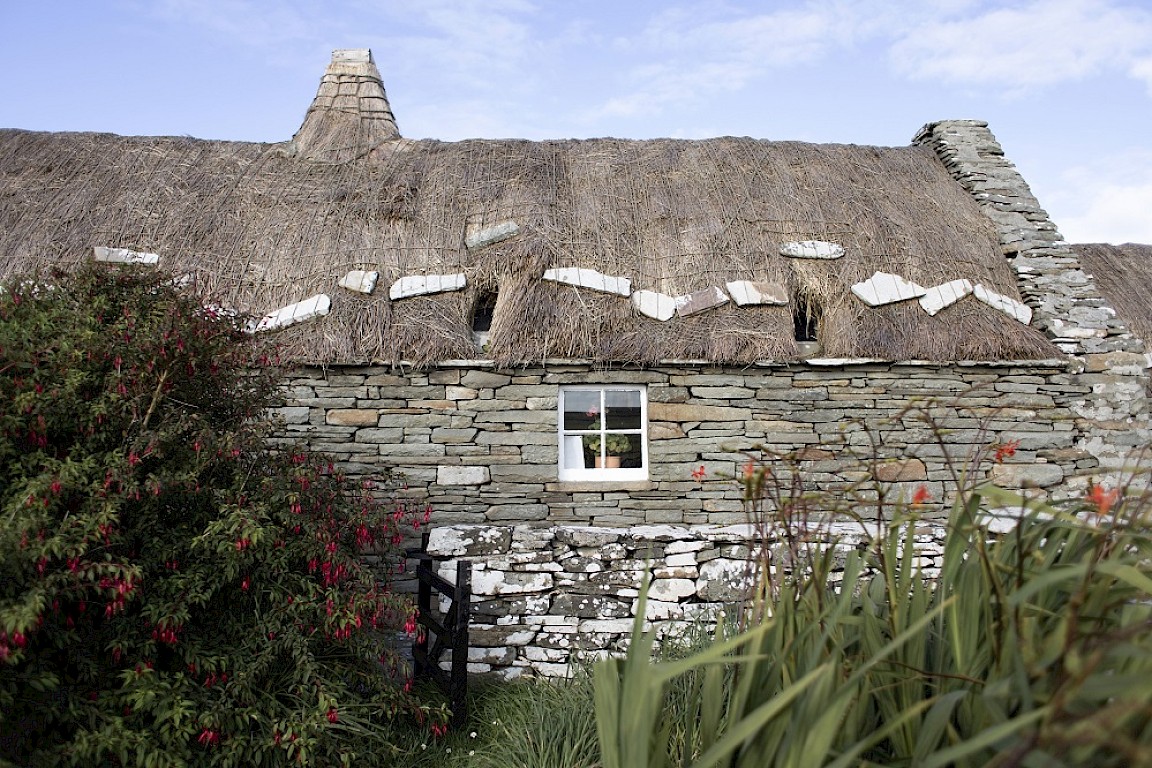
[427, 523, 946, 678]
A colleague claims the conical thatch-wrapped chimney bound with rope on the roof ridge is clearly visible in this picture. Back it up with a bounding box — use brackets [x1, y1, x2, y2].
[293, 48, 400, 162]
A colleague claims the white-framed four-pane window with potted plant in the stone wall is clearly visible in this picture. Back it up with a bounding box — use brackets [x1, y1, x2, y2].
[560, 385, 647, 480]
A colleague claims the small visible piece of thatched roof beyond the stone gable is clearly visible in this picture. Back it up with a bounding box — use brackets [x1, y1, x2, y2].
[1071, 243, 1152, 342]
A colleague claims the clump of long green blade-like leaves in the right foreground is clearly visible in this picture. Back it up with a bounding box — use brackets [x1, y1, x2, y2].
[593, 460, 1152, 768]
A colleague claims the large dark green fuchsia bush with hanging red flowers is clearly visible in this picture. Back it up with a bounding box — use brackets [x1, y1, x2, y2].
[0, 266, 442, 766]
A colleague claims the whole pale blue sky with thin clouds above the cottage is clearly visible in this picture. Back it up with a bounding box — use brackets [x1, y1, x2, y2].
[0, 0, 1152, 243]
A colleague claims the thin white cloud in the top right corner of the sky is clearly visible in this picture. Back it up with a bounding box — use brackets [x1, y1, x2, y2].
[889, 0, 1152, 91]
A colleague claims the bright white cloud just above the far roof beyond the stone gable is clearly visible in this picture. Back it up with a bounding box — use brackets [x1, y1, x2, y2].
[1041, 150, 1152, 244]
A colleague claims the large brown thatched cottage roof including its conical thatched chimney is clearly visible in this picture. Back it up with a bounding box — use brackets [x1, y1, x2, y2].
[0, 52, 1054, 364]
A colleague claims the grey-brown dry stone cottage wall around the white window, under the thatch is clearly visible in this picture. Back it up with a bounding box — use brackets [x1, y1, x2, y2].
[271, 360, 1115, 527]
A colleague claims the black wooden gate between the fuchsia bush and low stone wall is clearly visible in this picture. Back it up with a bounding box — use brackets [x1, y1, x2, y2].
[408, 533, 472, 728]
